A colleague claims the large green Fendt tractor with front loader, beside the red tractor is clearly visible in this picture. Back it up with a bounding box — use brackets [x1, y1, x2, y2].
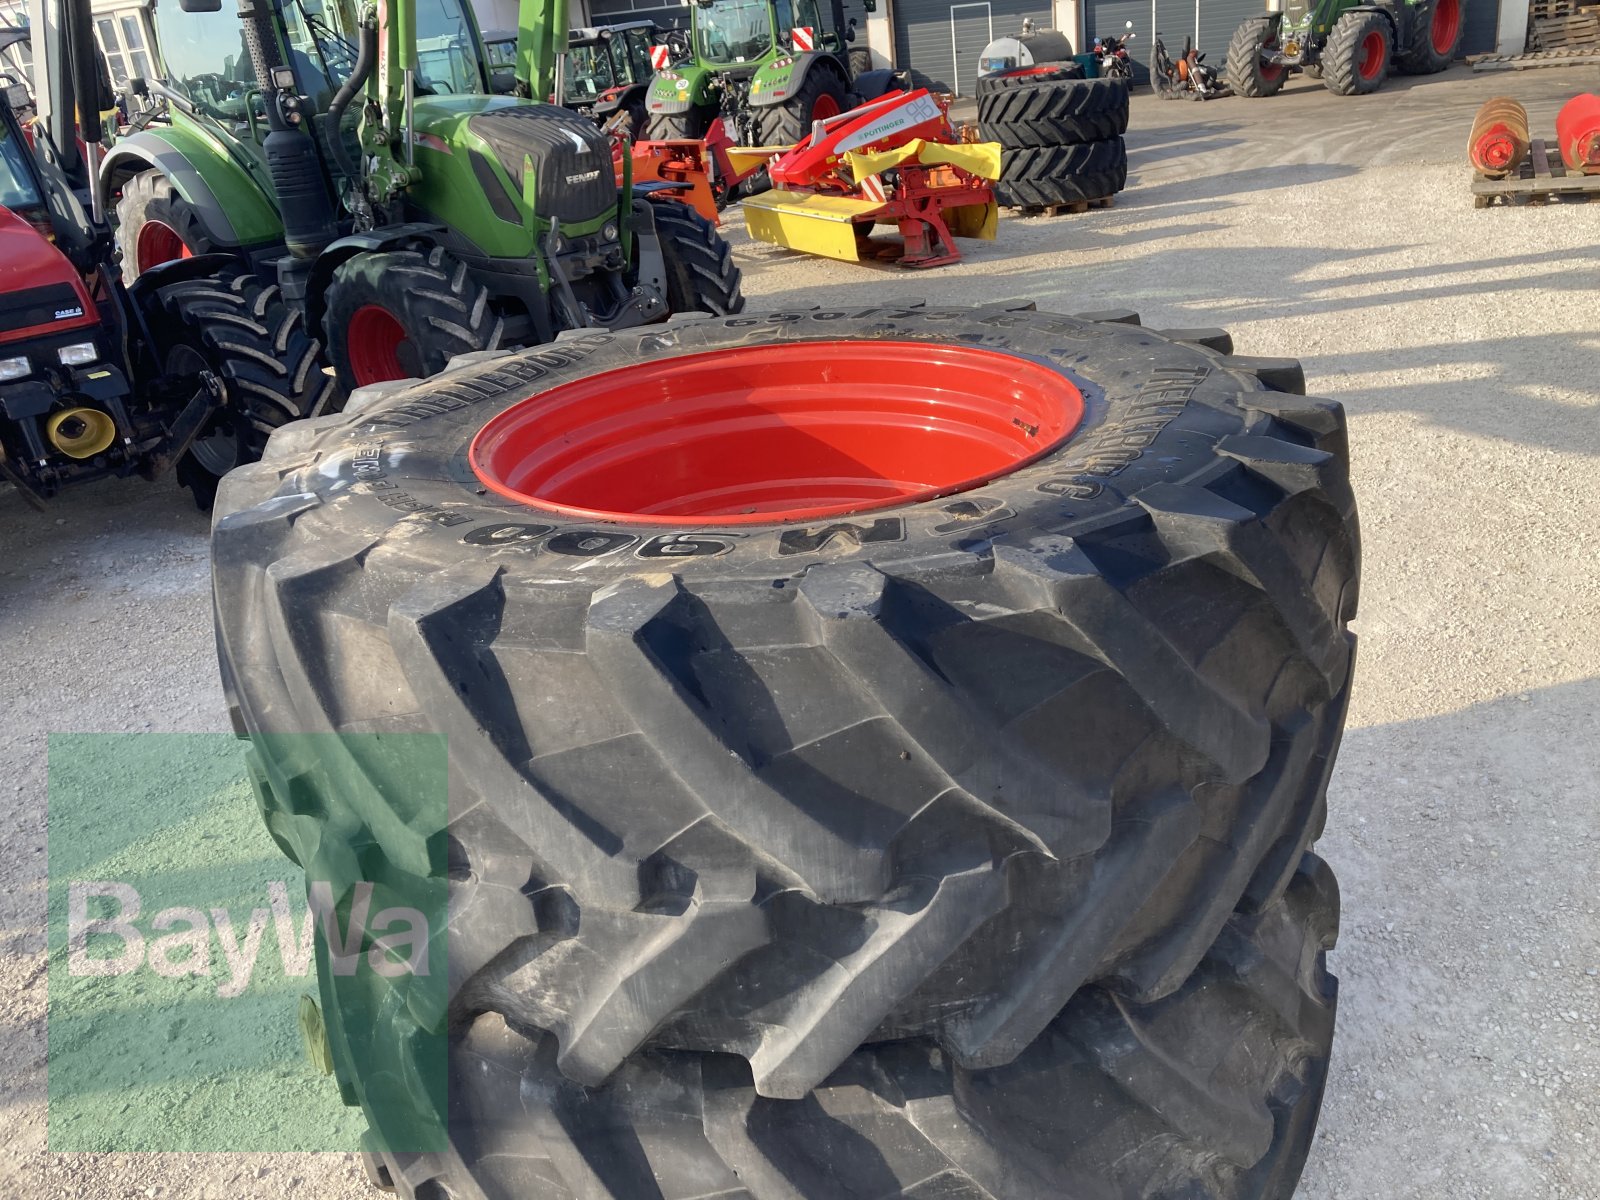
[101, 0, 742, 387]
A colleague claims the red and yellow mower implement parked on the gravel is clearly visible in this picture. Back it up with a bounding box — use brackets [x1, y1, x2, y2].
[728, 88, 1000, 267]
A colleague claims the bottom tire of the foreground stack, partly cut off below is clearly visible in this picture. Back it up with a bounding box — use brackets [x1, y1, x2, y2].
[368, 854, 1339, 1200]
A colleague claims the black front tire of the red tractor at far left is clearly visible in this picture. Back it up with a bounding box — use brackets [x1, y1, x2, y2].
[149, 269, 344, 509]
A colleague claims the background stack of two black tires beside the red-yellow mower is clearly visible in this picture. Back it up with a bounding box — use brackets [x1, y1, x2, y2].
[978, 62, 1128, 208]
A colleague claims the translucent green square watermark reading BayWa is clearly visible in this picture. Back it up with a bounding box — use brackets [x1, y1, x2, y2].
[48, 733, 448, 1152]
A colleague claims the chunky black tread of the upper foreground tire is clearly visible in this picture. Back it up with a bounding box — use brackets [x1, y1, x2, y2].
[218, 310, 1357, 1120]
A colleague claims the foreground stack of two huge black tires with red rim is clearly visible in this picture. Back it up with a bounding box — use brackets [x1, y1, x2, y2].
[213, 304, 1358, 1200]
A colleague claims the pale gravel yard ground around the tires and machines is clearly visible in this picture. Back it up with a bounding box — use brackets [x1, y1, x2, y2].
[0, 67, 1600, 1200]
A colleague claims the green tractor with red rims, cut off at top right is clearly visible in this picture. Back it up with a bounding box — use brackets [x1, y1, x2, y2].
[1226, 0, 1466, 96]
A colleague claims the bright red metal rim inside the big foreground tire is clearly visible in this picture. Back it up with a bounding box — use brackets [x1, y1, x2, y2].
[469, 341, 1083, 526]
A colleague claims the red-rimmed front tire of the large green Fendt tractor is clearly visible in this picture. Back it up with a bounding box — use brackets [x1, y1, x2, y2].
[322, 246, 504, 390]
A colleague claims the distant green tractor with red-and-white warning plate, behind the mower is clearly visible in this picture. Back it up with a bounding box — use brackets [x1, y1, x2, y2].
[645, 0, 899, 146]
